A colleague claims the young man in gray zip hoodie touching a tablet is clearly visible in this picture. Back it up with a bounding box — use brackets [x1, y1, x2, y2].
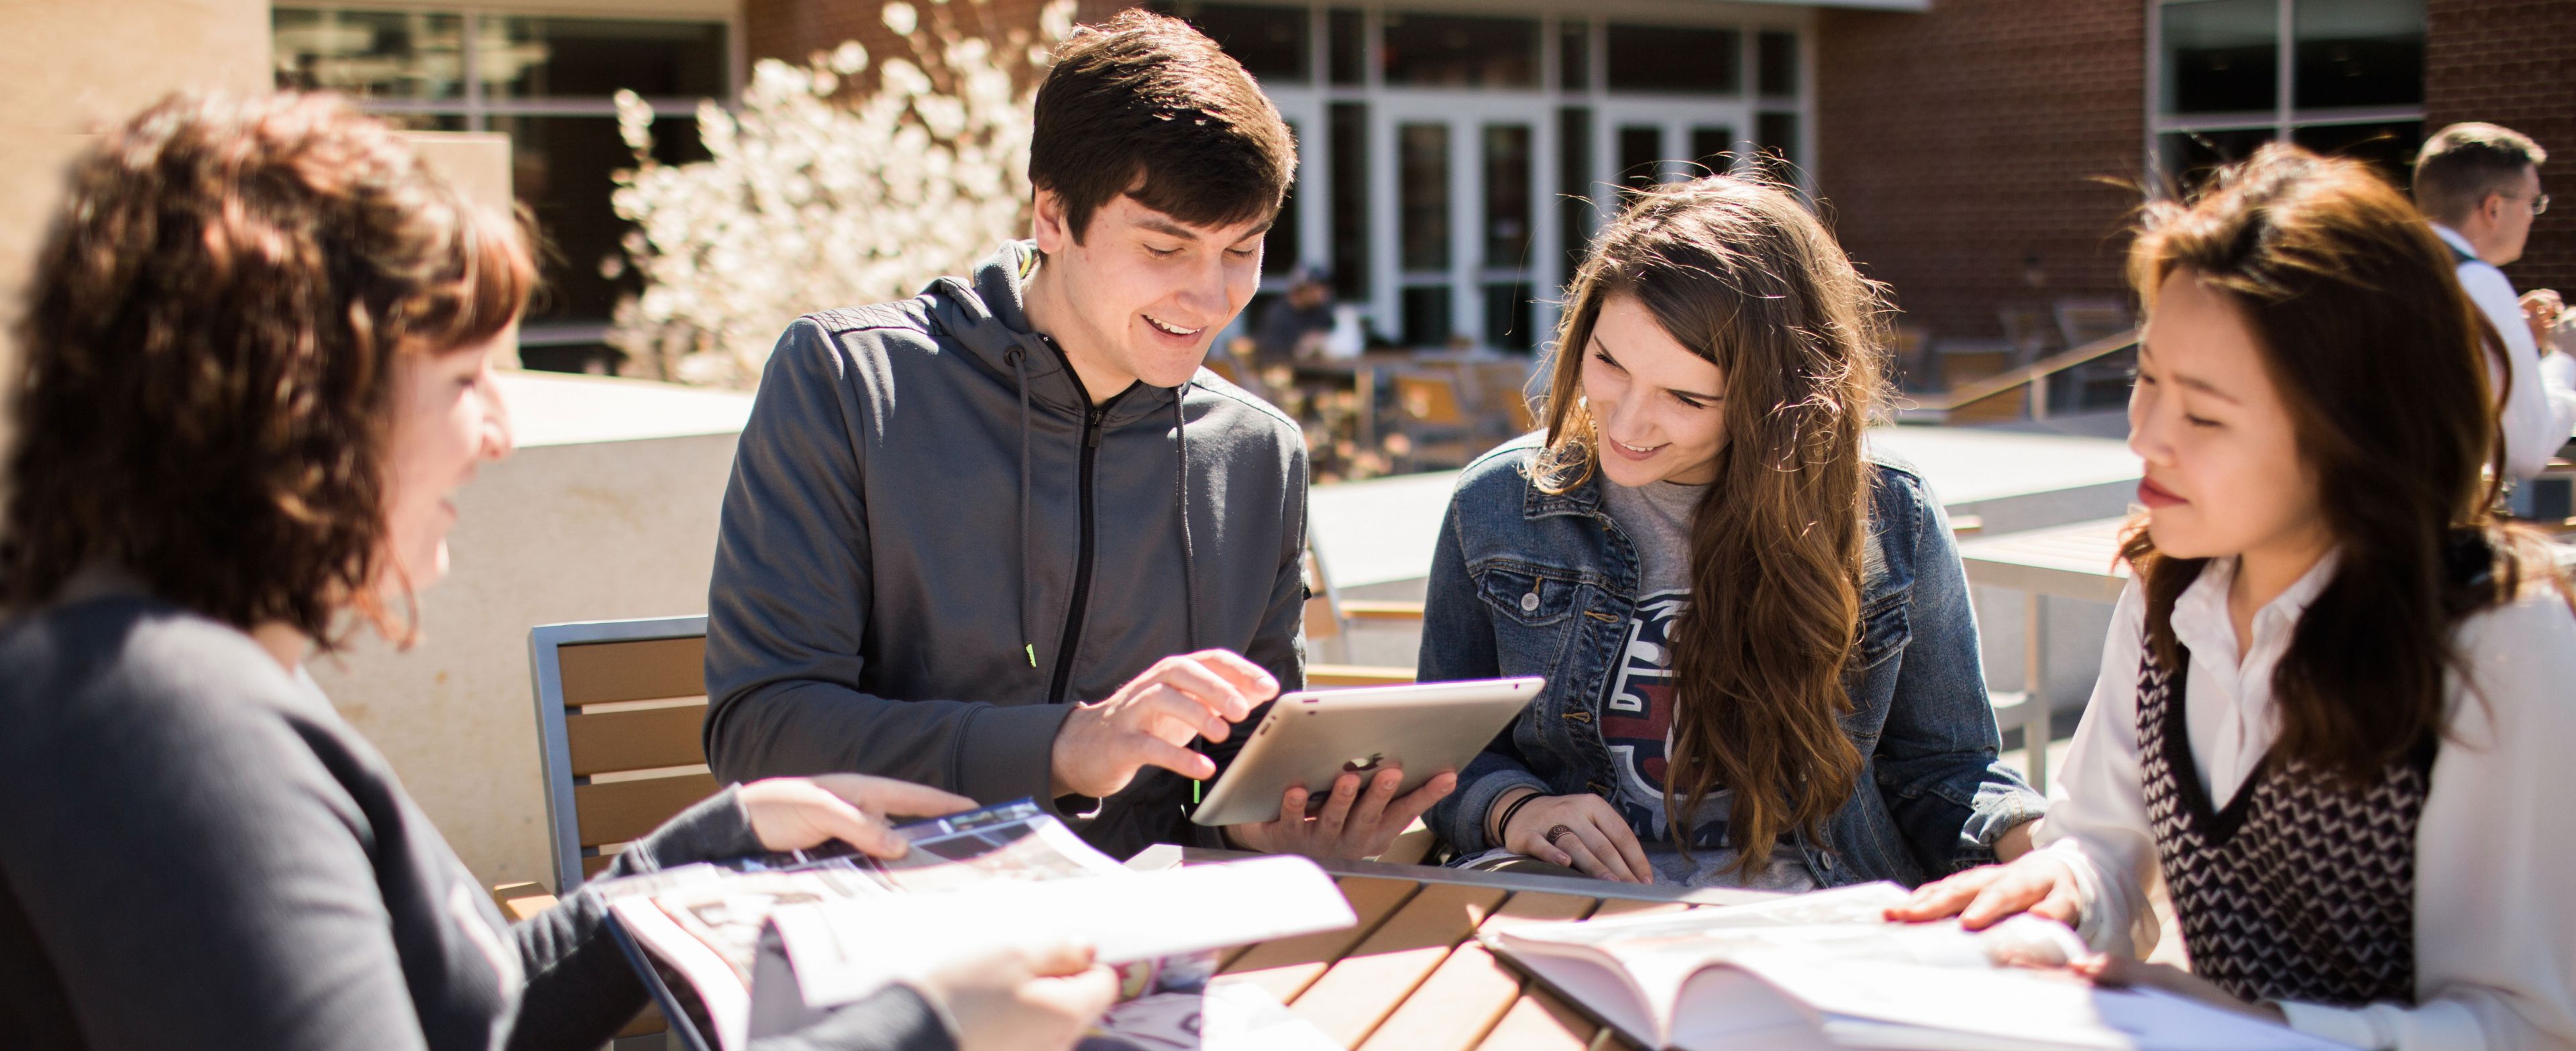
[706, 10, 1453, 858]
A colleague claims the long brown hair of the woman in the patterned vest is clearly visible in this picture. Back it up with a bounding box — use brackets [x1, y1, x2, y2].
[2123, 144, 2566, 785]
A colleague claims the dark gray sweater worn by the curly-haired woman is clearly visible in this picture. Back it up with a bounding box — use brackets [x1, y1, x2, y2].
[0, 598, 951, 1051]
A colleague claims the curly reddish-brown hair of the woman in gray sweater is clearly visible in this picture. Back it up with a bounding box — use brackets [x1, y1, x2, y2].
[0, 95, 533, 647]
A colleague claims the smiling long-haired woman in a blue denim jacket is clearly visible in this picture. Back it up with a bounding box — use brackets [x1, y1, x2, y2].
[1419, 175, 2043, 889]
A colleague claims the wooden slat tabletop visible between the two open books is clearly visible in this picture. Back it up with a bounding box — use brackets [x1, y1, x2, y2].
[1128, 848, 1772, 1051]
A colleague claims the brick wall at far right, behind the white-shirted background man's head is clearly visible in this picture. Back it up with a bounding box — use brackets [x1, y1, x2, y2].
[2424, 0, 2576, 291]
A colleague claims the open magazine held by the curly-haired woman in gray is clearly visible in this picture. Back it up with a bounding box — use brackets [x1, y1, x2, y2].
[595, 799, 1355, 1051]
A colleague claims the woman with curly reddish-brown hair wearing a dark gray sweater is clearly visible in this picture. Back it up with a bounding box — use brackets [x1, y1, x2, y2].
[0, 95, 1113, 1048]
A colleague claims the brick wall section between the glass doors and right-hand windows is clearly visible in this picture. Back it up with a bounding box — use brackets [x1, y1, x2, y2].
[1816, 0, 2146, 347]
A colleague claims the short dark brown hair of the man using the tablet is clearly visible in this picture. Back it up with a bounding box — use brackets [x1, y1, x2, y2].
[1028, 8, 1296, 242]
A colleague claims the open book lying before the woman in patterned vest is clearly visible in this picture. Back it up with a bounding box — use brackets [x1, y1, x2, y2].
[1479, 883, 2339, 1051]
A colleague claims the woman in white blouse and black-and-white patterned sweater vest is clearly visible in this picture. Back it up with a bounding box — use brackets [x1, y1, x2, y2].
[1893, 147, 2576, 1048]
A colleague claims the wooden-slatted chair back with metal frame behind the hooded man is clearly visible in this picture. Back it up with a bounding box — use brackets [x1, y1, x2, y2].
[528, 616, 716, 897]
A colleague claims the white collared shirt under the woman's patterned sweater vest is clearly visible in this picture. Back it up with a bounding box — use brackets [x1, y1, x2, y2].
[2037, 557, 2576, 1051]
